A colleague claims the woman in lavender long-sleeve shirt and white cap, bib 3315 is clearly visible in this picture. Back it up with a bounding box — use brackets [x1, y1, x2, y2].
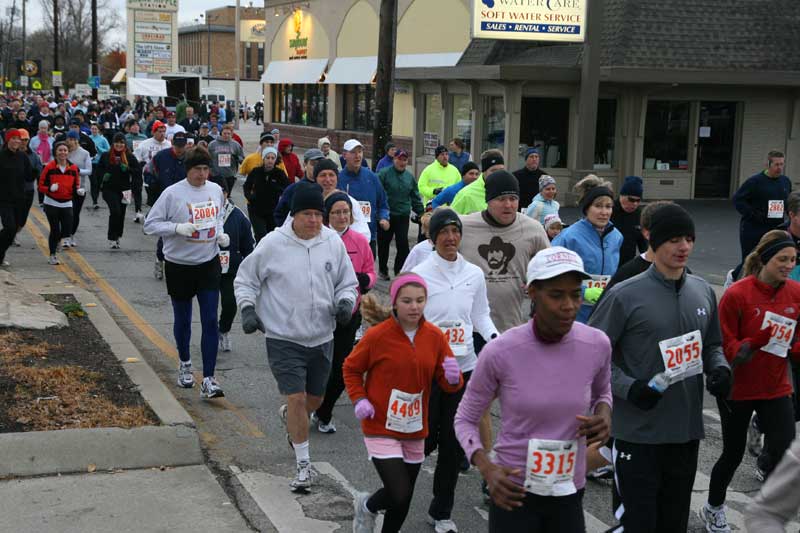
[455, 247, 611, 533]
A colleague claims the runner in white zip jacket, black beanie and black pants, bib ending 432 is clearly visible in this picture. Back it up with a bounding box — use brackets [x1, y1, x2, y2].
[412, 208, 498, 531]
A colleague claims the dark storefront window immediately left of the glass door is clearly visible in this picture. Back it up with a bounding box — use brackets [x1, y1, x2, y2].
[643, 101, 690, 170]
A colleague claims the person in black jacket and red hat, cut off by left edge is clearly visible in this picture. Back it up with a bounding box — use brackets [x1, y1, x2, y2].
[0, 129, 33, 267]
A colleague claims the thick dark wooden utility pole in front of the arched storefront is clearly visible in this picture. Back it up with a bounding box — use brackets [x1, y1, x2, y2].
[372, 0, 397, 170]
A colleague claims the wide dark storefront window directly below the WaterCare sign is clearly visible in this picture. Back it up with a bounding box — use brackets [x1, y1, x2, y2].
[517, 98, 569, 168]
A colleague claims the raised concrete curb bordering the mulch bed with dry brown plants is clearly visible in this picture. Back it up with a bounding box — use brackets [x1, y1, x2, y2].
[0, 283, 204, 477]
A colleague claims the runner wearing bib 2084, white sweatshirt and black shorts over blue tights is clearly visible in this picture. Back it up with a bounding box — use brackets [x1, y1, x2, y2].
[144, 147, 225, 399]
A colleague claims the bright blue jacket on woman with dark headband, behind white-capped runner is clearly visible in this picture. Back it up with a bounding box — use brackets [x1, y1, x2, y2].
[552, 218, 622, 324]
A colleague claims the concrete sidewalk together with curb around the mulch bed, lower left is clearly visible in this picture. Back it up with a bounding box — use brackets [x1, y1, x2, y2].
[0, 232, 251, 533]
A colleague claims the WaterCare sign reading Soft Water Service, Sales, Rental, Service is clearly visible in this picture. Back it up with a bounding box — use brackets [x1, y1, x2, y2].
[472, 0, 589, 42]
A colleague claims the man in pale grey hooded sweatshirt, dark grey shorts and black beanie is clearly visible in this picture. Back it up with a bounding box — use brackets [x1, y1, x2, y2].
[233, 185, 358, 492]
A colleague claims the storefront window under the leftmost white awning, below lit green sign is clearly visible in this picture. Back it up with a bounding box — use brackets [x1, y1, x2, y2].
[272, 83, 328, 128]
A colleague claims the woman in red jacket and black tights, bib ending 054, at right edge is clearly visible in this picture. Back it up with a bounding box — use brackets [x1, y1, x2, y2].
[700, 230, 800, 531]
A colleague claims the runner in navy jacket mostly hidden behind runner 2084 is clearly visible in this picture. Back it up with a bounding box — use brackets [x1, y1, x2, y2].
[214, 179, 255, 352]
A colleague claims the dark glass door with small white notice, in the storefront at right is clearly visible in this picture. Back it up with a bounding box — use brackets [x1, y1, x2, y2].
[694, 102, 736, 198]
